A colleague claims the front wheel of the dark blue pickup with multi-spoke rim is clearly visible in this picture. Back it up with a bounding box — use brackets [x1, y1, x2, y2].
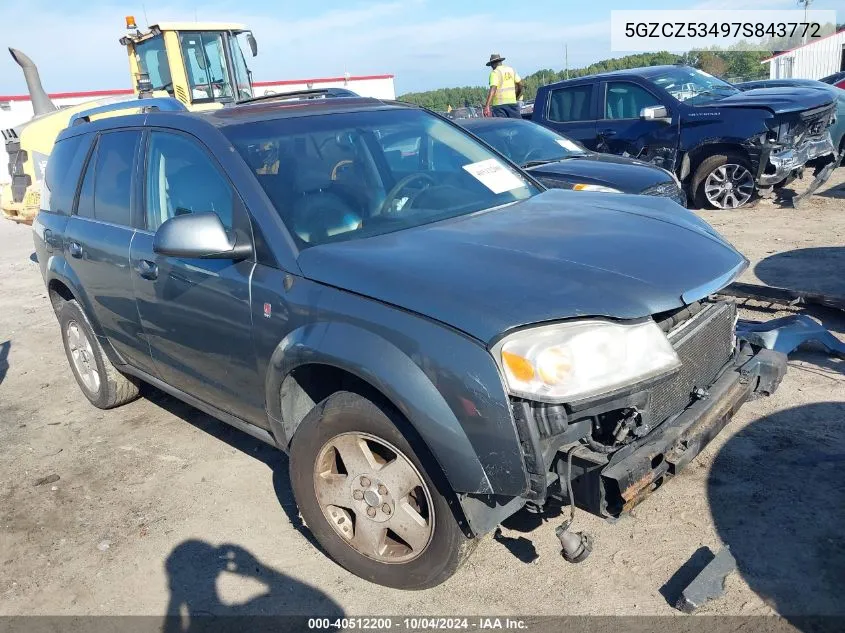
[690, 154, 756, 209]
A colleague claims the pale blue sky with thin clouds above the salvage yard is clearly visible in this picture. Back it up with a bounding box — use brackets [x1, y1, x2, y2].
[0, 0, 845, 95]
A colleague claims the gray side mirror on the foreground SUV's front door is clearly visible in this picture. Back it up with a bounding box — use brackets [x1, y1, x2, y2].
[153, 213, 252, 259]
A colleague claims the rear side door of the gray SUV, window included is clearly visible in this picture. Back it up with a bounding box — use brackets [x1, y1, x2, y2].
[64, 130, 152, 371]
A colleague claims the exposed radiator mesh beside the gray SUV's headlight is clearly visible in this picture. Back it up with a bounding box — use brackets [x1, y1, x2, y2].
[649, 302, 736, 424]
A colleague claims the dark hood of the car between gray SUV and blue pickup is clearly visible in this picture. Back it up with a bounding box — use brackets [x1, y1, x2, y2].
[527, 153, 673, 193]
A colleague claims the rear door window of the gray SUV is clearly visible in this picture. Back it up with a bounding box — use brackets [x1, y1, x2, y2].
[76, 130, 141, 226]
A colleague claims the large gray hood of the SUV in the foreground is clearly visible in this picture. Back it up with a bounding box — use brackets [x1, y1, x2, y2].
[299, 190, 748, 343]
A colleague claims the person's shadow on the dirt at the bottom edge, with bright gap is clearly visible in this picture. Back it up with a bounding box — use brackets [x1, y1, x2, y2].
[162, 539, 344, 633]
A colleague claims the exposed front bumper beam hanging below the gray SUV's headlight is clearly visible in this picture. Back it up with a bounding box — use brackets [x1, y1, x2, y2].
[572, 349, 786, 517]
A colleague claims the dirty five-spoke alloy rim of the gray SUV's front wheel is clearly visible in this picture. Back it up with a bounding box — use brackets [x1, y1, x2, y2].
[314, 433, 434, 563]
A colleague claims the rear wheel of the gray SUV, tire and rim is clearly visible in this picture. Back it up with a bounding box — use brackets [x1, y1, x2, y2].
[59, 301, 138, 409]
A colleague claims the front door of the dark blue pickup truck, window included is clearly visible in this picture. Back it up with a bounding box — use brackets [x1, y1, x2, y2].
[595, 81, 679, 171]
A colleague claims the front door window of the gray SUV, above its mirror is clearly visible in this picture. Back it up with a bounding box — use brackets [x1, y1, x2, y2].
[145, 132, 234, 231]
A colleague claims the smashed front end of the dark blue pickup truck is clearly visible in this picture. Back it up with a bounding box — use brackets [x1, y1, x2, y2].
[751, 105, 836, 187]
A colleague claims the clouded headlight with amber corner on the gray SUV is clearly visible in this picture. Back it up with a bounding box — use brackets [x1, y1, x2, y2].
[493, 320, 681, 402]
